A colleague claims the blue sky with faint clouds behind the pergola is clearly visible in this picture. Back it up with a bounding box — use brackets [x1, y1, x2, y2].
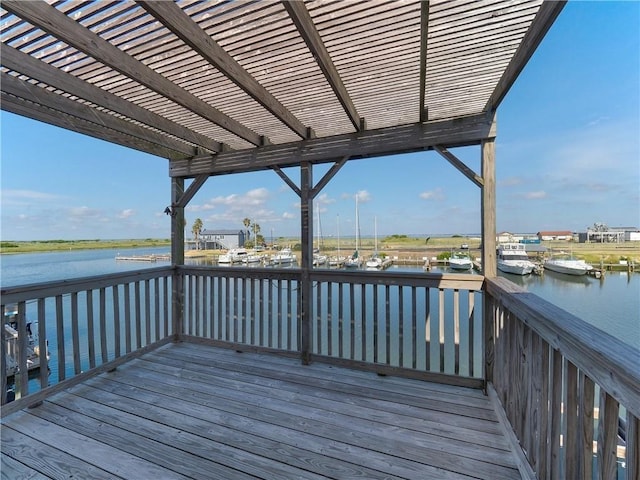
[0, 1, 640, 240]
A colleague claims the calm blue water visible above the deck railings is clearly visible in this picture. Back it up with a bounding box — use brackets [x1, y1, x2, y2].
[0, 247, 640, 349]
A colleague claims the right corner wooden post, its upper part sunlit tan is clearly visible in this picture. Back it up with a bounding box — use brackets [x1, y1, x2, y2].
[480, 118, 497, 391]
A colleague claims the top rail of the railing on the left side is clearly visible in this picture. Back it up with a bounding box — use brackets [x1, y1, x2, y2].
[0, 266, 174, 305]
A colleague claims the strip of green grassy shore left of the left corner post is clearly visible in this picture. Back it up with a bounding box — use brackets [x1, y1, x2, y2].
[0, 238, 171, 255]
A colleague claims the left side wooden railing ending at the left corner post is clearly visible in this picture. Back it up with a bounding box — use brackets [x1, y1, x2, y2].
[0, 267, 175, 404]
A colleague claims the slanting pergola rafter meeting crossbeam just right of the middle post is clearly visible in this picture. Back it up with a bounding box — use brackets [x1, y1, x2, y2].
[282, 0, 365, 131]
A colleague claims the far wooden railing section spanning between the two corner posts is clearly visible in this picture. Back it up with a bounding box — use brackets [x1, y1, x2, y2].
[180, 267, 483, 387]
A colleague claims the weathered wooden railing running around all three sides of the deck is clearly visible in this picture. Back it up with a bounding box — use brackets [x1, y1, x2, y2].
[0, 267, 640, 480]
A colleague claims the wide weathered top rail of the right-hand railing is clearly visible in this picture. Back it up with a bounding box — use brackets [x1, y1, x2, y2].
[485, 277, 640, 417]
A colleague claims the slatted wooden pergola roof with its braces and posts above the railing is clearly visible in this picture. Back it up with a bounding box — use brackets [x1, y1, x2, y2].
[0, 0, 564, 276]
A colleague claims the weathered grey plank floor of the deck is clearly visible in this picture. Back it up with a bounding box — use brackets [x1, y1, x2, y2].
[1, 343, 521, 480]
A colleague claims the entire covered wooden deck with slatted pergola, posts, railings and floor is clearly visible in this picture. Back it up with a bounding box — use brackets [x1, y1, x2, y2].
[0, 0, 640, 480]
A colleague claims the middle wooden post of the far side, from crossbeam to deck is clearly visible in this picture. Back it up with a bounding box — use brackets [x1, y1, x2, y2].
[299, 162, 313, 365]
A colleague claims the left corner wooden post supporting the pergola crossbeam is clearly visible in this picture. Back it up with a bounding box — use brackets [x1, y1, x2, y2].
[171, 178, 185, 341]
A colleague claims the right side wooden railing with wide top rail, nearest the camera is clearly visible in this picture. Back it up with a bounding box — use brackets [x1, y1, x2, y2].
[485, 278, 640, 480]
